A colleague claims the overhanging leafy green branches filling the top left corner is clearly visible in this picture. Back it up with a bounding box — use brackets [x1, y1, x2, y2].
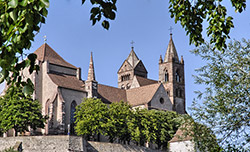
[0, 0, 49, 94]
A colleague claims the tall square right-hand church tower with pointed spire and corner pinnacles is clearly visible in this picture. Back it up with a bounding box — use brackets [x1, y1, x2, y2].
[159, 33, 185, 114]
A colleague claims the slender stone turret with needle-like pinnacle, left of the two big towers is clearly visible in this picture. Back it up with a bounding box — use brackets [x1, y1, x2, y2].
[85, 52, 98, 98]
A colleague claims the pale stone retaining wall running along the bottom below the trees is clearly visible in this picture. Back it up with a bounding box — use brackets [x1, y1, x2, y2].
[0, 136, 163, 152]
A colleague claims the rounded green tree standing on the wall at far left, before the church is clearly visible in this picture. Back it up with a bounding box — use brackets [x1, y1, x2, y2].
[0, 87, 46, 135]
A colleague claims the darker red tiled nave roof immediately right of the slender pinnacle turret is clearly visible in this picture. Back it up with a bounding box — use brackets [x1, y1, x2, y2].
[97, 84, 127, 102]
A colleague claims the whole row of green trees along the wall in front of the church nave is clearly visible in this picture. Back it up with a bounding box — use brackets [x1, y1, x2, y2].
[75, 98, 182, 149]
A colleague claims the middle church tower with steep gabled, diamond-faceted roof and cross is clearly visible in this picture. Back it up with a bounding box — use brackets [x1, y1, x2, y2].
[117, 46, 148, 89]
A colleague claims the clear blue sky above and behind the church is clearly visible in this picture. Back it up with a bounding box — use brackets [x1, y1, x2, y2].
[2, 0, 250, 113]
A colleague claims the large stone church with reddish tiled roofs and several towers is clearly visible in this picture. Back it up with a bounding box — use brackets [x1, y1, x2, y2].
[3, 34, 186, 134]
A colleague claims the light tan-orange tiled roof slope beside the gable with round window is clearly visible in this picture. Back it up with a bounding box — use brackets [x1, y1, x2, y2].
[126, 83, 160, 106]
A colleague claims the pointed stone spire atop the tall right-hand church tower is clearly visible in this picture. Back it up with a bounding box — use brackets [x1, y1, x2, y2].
[164, 33, 179, 62]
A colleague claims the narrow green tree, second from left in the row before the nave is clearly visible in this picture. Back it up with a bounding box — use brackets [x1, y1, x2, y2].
[105, 101, 132, 143]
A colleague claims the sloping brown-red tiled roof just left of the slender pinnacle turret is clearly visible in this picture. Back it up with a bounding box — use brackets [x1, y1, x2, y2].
[48, 73, 85, 92]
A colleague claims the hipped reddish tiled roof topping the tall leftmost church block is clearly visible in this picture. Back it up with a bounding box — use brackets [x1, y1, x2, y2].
[34, 43, 76, 69]
